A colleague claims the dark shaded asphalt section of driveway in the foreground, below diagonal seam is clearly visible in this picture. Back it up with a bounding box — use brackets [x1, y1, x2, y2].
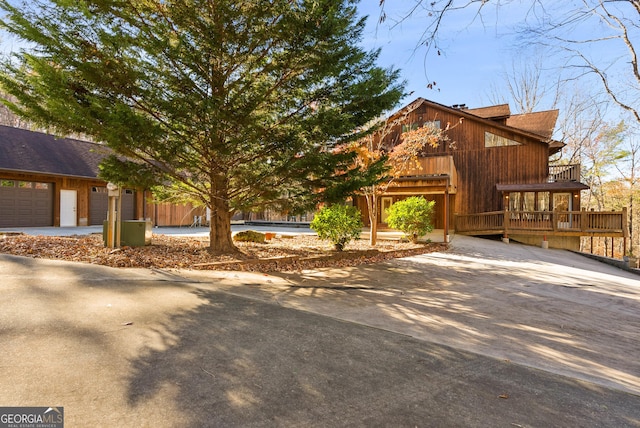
[128, 290, 640, 427]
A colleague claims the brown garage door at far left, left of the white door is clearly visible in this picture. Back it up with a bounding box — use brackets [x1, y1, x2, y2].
[0, 180, 53, 227]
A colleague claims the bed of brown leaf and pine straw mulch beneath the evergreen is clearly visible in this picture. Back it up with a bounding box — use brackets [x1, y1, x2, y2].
[0, 234, 447, 272]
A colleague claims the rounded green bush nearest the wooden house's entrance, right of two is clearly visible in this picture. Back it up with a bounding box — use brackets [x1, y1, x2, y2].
[387, 196, 435, 243]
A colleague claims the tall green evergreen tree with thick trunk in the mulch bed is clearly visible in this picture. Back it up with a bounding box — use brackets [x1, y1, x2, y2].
[0, 0, 402, 252]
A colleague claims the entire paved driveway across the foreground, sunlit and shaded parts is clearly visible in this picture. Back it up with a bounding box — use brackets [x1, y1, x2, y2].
[0, 236, 640, 427]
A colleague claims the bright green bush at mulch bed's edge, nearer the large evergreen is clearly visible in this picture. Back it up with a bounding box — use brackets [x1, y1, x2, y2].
[311, 205, 363, 251]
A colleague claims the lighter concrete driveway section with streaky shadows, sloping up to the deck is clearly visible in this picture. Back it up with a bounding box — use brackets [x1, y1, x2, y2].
[266, 247, 640, 394]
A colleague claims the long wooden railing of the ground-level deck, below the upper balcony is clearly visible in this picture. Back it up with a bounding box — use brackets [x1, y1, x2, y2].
[455, 209, 628, 237]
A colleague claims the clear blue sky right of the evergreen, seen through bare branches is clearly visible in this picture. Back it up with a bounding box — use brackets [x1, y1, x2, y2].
[358, 0, 640, 115]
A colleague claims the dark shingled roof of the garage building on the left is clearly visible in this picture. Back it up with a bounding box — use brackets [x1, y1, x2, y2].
[0, 126, 112, 178]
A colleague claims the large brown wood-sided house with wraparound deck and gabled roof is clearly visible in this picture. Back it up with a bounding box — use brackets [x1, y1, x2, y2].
[355, 98, 627, 249]
